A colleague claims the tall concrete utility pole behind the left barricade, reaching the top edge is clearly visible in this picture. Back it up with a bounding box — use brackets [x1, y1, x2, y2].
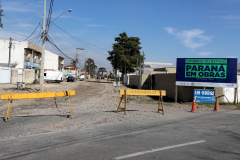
[40, 0, 46, 92]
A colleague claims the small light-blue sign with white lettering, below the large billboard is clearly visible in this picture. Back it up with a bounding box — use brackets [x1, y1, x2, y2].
[194, 89, 216, 103]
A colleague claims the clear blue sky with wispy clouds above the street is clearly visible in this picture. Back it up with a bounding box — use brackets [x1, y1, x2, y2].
[0, 0, 240, 71]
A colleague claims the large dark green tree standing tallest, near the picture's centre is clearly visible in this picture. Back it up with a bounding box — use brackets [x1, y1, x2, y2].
[107, 32, 143, 74]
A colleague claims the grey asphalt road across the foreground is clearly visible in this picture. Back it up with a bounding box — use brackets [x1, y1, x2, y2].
[0, 111, 240, 160]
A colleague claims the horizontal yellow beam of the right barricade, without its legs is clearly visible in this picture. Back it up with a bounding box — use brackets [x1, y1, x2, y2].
[120, 89, 166, 96]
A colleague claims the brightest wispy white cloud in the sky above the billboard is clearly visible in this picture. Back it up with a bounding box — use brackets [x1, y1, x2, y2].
[165, 27, 212, 49]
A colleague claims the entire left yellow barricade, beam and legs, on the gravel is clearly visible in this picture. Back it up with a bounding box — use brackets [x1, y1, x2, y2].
[0, 90, 75, 121]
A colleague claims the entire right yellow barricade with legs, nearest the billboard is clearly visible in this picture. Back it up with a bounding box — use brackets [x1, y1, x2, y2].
[117, 89, 166, 115]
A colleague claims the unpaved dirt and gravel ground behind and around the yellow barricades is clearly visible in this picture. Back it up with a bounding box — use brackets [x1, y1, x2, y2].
[0, 80, 237, 139]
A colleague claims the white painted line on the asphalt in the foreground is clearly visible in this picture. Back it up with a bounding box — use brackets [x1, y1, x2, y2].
[115, 140, 205, 159]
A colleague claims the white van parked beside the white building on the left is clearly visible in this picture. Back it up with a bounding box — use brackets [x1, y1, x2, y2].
[44, 70, 63, 83]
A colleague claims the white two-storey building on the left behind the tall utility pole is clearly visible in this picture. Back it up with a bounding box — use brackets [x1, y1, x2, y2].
[0, 39, 64, 70]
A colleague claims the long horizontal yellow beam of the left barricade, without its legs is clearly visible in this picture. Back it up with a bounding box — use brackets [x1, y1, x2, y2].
[0, 90, 75, 99]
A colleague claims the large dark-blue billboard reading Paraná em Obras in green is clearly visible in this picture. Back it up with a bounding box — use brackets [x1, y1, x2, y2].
[176, 58, 237, 88]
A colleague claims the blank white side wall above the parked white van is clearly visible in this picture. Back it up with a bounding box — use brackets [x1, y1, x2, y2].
[44, 50, 58, 70]
